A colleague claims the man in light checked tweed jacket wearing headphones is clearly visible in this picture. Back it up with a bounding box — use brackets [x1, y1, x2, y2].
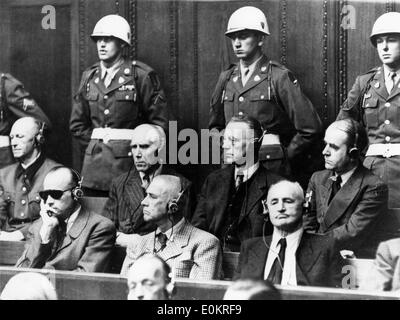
[121, 175, 222, 280]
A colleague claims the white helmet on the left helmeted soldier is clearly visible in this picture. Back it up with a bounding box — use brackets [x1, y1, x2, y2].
[90, 14, 131, 45]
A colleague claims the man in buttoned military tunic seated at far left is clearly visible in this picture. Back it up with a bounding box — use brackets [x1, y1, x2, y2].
[0, 117, 58, 241]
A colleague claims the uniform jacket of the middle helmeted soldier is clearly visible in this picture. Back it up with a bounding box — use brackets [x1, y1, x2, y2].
[209, 56, 322, 164]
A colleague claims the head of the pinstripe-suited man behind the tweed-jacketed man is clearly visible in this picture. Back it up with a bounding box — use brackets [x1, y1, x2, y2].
[131, 124, 166, 172]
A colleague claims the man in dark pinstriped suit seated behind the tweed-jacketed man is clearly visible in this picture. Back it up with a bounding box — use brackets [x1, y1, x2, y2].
[104, 124, 191, 247]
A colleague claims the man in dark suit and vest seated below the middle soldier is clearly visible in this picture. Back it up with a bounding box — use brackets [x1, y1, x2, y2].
[192, 114, 280, 251]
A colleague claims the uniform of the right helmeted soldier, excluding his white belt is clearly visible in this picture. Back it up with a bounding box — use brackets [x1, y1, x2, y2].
[337, 67, 400, 208]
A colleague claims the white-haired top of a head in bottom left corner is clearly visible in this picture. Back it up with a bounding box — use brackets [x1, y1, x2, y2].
[0, 272, 57, 300]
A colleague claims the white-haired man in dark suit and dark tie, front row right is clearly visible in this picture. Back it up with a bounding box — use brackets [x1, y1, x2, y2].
[236, 180, 343, 287]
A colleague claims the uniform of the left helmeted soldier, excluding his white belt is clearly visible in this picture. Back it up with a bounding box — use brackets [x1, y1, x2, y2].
[70, 59, 168, 191]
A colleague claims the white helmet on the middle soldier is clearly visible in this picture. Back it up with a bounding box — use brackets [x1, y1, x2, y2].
[225, 6, 269, 36]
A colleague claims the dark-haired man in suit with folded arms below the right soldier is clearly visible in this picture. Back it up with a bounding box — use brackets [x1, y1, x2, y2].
[304, 119, 388, 258]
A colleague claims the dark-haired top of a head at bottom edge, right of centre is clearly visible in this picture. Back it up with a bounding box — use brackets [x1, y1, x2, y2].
[224, 278, 282, 300]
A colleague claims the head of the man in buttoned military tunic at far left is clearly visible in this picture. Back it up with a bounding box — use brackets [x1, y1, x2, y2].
[10, 117, 41, 163]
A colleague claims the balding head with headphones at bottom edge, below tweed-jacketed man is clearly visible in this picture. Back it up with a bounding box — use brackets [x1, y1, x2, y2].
[128, 255, 175, 300]
